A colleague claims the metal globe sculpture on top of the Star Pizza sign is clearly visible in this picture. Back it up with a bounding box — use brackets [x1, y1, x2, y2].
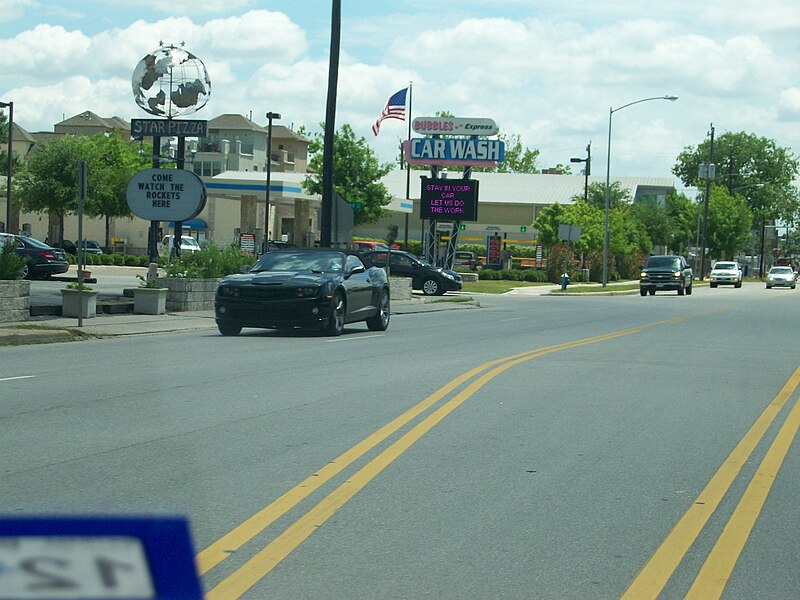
[131, 45, 211, 119]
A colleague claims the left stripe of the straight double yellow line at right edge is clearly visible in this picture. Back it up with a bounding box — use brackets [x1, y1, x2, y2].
[622, 367, 800, 600]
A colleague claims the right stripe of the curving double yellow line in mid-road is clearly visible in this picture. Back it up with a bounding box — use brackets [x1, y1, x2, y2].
[206, 327, 642, 600]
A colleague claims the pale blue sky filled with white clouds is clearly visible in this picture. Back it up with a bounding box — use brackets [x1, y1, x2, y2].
[0, 0, 800, 189]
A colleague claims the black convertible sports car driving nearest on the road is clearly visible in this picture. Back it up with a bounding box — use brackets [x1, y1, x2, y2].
[214, 248, 389, 335]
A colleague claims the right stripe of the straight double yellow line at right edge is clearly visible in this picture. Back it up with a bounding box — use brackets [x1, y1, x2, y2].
[686, 372, 800, 600]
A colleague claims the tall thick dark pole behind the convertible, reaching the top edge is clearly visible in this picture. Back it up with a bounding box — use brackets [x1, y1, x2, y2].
[319, 0, 342, 248]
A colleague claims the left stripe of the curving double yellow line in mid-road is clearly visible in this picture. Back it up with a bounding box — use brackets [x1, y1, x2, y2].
[197, 321, 669, 575]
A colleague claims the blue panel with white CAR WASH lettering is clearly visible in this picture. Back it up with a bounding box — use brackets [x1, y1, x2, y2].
[403, 137, 506, 167]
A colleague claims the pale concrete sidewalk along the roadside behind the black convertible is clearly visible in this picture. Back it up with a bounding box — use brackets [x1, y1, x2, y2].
[0, 296, 480, 346]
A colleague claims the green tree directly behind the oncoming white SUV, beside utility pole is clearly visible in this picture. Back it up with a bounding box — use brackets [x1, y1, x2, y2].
[707, 185, 753, 259]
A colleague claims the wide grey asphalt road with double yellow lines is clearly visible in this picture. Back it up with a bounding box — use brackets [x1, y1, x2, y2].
[0, 284, 800, 600]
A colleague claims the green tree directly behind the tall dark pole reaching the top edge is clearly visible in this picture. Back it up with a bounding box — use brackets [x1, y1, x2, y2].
[298, 123, 392, 225]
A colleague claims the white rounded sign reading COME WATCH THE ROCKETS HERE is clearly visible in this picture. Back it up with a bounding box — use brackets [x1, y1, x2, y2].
[126, 169, 206, 221]
